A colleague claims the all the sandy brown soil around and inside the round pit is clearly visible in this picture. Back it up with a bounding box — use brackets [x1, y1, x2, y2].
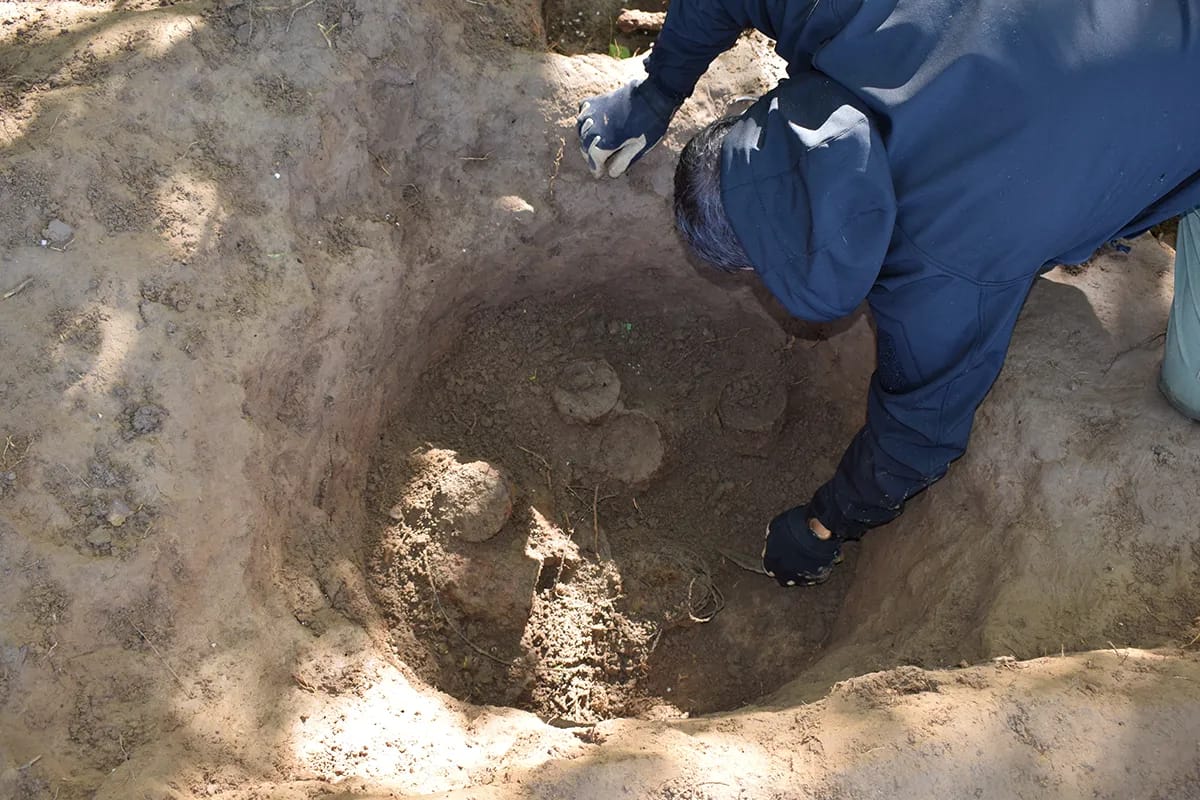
[0, 0, 1200, 800]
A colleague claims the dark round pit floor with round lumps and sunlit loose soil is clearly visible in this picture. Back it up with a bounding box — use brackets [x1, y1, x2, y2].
[367, 281, 865, 722]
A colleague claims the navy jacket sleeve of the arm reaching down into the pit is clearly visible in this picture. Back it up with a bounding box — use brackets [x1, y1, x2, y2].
[810, 270, 1033, 539]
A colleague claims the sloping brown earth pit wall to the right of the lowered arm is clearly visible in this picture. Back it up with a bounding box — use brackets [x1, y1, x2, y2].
[782, 236, 1200, 698]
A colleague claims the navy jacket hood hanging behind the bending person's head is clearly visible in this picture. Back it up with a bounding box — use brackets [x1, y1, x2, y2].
[721, 72, 896, 321]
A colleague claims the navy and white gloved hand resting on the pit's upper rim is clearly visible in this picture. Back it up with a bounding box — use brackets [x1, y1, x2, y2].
[575, 80, 682, 178]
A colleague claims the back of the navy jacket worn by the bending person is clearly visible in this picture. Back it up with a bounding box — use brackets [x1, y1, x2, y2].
[816, 0, 1200, 281]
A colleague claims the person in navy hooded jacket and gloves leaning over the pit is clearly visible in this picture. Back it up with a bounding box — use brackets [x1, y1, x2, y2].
[577, 0, 1200, 585]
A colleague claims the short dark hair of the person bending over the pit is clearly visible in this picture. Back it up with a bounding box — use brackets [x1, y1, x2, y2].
[674, 116, 751, 272]
